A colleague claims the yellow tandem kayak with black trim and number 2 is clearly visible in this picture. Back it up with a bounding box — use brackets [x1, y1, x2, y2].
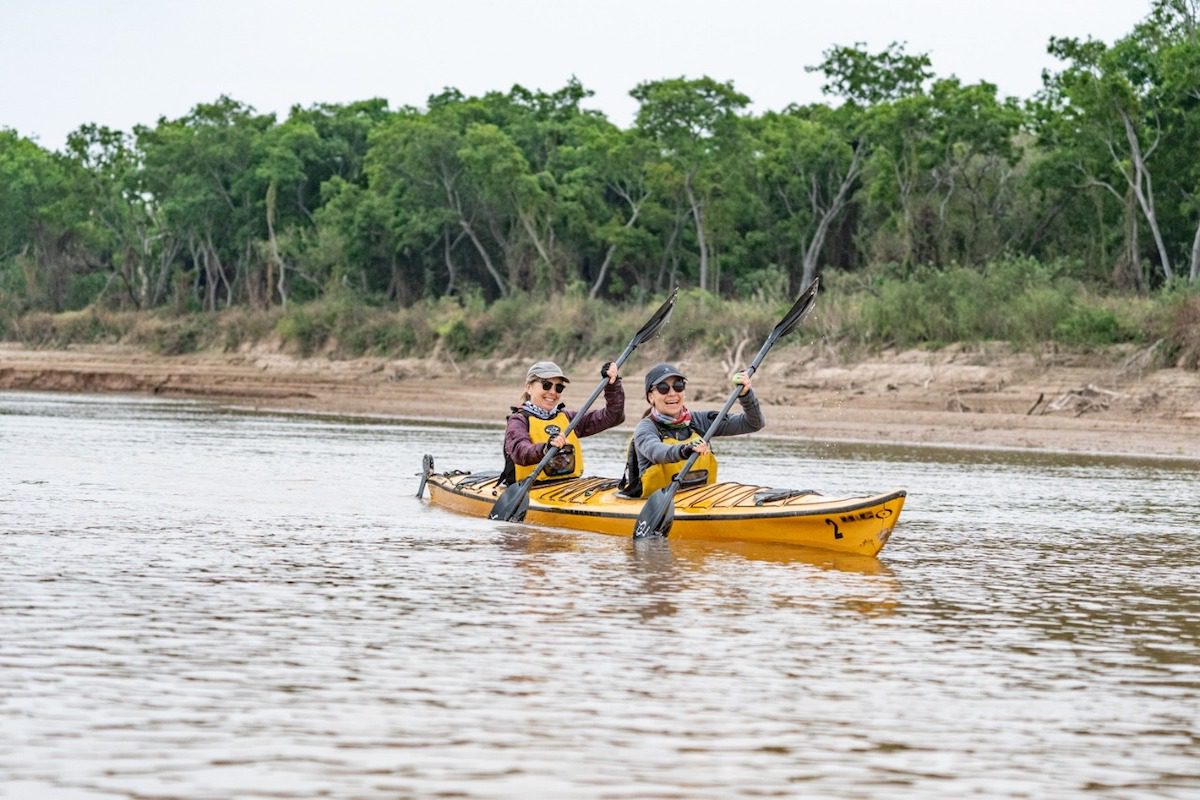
[426, 462, 906, 557]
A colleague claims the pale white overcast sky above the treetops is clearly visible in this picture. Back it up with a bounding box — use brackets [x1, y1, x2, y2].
[0, 0, 1150, 150]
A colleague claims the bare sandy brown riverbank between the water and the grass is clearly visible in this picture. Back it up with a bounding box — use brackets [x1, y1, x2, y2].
[0, 344, 1200, 462]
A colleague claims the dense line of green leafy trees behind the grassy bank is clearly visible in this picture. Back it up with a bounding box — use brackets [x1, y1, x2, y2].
[0, 0, 1200, 321]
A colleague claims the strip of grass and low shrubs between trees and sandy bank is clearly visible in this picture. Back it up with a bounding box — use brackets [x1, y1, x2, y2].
[0, 260, 1200, 369]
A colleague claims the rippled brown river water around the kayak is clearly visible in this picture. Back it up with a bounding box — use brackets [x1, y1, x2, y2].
[0, 393, 1200, 799]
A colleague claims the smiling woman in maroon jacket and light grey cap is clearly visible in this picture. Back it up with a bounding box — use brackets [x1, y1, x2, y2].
[503, 361, 625, 483]
